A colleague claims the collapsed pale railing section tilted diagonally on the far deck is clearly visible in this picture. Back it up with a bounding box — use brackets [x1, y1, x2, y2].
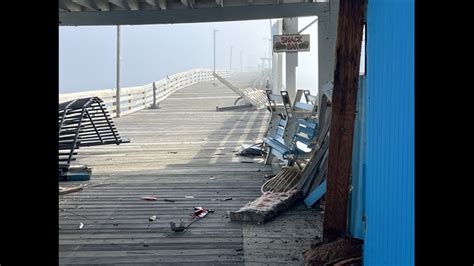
[212, 73, 268, 111]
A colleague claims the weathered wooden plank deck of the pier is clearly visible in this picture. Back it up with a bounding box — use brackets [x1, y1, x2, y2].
[59, 71, 322, 265]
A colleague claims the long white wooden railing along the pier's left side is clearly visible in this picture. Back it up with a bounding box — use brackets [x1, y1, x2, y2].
[59, 69, 230, 116]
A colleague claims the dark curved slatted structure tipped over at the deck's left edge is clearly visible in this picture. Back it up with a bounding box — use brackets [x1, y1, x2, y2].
[58, 97, 130, 180]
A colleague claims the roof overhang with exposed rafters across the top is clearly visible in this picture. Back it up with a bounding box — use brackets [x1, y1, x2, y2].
[59, 0, 329, 26]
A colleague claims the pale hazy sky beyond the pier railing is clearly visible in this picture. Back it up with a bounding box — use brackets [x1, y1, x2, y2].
[59, 17, 317, 93]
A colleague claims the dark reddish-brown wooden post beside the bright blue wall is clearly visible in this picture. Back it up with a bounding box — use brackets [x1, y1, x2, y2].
[323, 0, 367, 240]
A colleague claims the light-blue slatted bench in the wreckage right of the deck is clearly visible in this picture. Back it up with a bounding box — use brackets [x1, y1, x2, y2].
[263, 119, 318, 165]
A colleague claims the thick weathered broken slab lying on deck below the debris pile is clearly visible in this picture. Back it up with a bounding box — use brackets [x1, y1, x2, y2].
[230, 189, 302, 224]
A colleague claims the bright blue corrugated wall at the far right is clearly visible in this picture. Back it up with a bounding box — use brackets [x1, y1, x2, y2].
[364, 0, 415, 265]
